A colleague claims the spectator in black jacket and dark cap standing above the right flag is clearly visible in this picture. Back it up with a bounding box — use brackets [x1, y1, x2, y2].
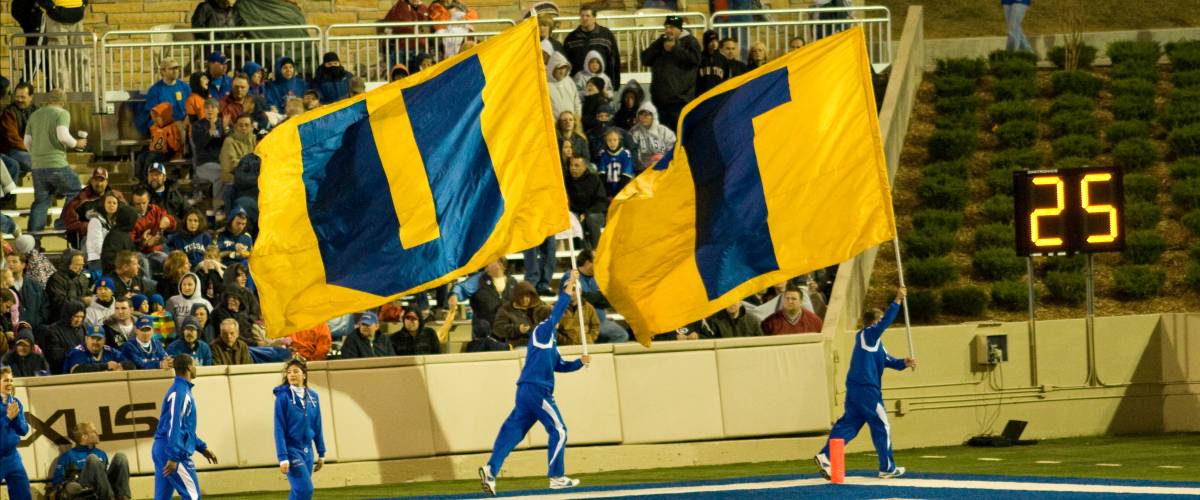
[642, 16, 700, 131]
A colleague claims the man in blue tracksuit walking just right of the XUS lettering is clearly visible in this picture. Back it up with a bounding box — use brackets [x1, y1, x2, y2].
[150, 354, 217, 500]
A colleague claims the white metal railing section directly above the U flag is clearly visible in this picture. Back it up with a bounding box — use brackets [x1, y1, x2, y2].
[323, 19, 516, 82]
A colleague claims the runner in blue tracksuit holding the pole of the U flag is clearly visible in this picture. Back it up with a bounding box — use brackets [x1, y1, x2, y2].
[479, 271, 592, 495]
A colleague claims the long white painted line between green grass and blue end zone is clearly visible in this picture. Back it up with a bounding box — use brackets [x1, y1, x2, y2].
[501, 476, 1200, 500]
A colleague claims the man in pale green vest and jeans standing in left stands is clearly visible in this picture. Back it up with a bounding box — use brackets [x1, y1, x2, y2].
[25, 89, 88, 231]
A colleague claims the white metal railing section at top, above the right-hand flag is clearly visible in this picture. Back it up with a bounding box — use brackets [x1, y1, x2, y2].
[712, 5, 892, 66]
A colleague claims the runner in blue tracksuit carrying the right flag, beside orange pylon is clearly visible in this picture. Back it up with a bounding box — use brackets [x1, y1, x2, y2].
[815, 288, 917, 480]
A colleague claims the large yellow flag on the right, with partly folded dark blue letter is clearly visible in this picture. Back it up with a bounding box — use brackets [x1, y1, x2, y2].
[595, 29, 895, 344]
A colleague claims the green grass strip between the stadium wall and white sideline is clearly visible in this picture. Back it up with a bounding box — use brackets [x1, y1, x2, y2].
[209, 433, 1200, 500]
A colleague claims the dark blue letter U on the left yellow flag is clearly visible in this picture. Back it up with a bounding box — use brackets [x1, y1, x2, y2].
[299, 56, 504, 296]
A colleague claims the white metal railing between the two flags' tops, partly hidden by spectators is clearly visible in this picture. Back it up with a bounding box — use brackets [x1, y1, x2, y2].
[553, 11, 708, 73]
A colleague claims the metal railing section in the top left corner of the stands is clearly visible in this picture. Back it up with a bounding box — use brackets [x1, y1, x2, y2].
[8, 31, 98, 106]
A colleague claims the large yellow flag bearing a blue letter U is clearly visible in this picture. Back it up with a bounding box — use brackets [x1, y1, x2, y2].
[250, 20, 569, 337]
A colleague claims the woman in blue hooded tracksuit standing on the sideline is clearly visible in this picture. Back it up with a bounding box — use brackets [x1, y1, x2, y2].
[275, 359, 325, 500]
